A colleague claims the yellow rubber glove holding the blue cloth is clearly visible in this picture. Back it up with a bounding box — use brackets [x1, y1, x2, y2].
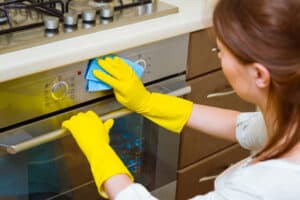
[93, 57, 193, 133]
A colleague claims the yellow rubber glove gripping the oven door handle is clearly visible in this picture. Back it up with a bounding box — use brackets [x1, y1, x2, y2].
[62, 111, 133, 198]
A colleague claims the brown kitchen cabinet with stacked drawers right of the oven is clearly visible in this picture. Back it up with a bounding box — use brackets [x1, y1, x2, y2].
[176, 29, 255, 200]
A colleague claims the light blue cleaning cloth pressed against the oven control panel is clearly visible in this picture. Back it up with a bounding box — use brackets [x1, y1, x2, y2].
[84, 55, 144, 92]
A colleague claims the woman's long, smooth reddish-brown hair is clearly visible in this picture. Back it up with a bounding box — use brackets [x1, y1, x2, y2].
[213, 0, 300, 161]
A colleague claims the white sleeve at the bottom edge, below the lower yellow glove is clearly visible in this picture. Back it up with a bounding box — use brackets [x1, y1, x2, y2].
[115, 183, 157, 200]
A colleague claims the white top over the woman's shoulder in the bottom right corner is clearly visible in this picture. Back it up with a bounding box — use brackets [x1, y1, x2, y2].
[193, 158, 300, 200]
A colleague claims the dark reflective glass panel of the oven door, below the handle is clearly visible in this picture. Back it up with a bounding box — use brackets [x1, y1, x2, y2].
[0, 114, 178, 200]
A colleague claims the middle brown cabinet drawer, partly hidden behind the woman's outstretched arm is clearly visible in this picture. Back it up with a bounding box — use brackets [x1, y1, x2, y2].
[179, 71, 255, 169]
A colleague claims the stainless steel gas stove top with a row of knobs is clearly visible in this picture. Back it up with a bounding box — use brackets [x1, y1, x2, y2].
[0, 0, 178, 53]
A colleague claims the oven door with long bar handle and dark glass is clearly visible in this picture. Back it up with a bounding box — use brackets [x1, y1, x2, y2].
[0, 75, 190, 200]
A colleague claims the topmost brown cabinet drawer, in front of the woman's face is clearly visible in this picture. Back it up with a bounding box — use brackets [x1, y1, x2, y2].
[187, 28, 221, 80]
